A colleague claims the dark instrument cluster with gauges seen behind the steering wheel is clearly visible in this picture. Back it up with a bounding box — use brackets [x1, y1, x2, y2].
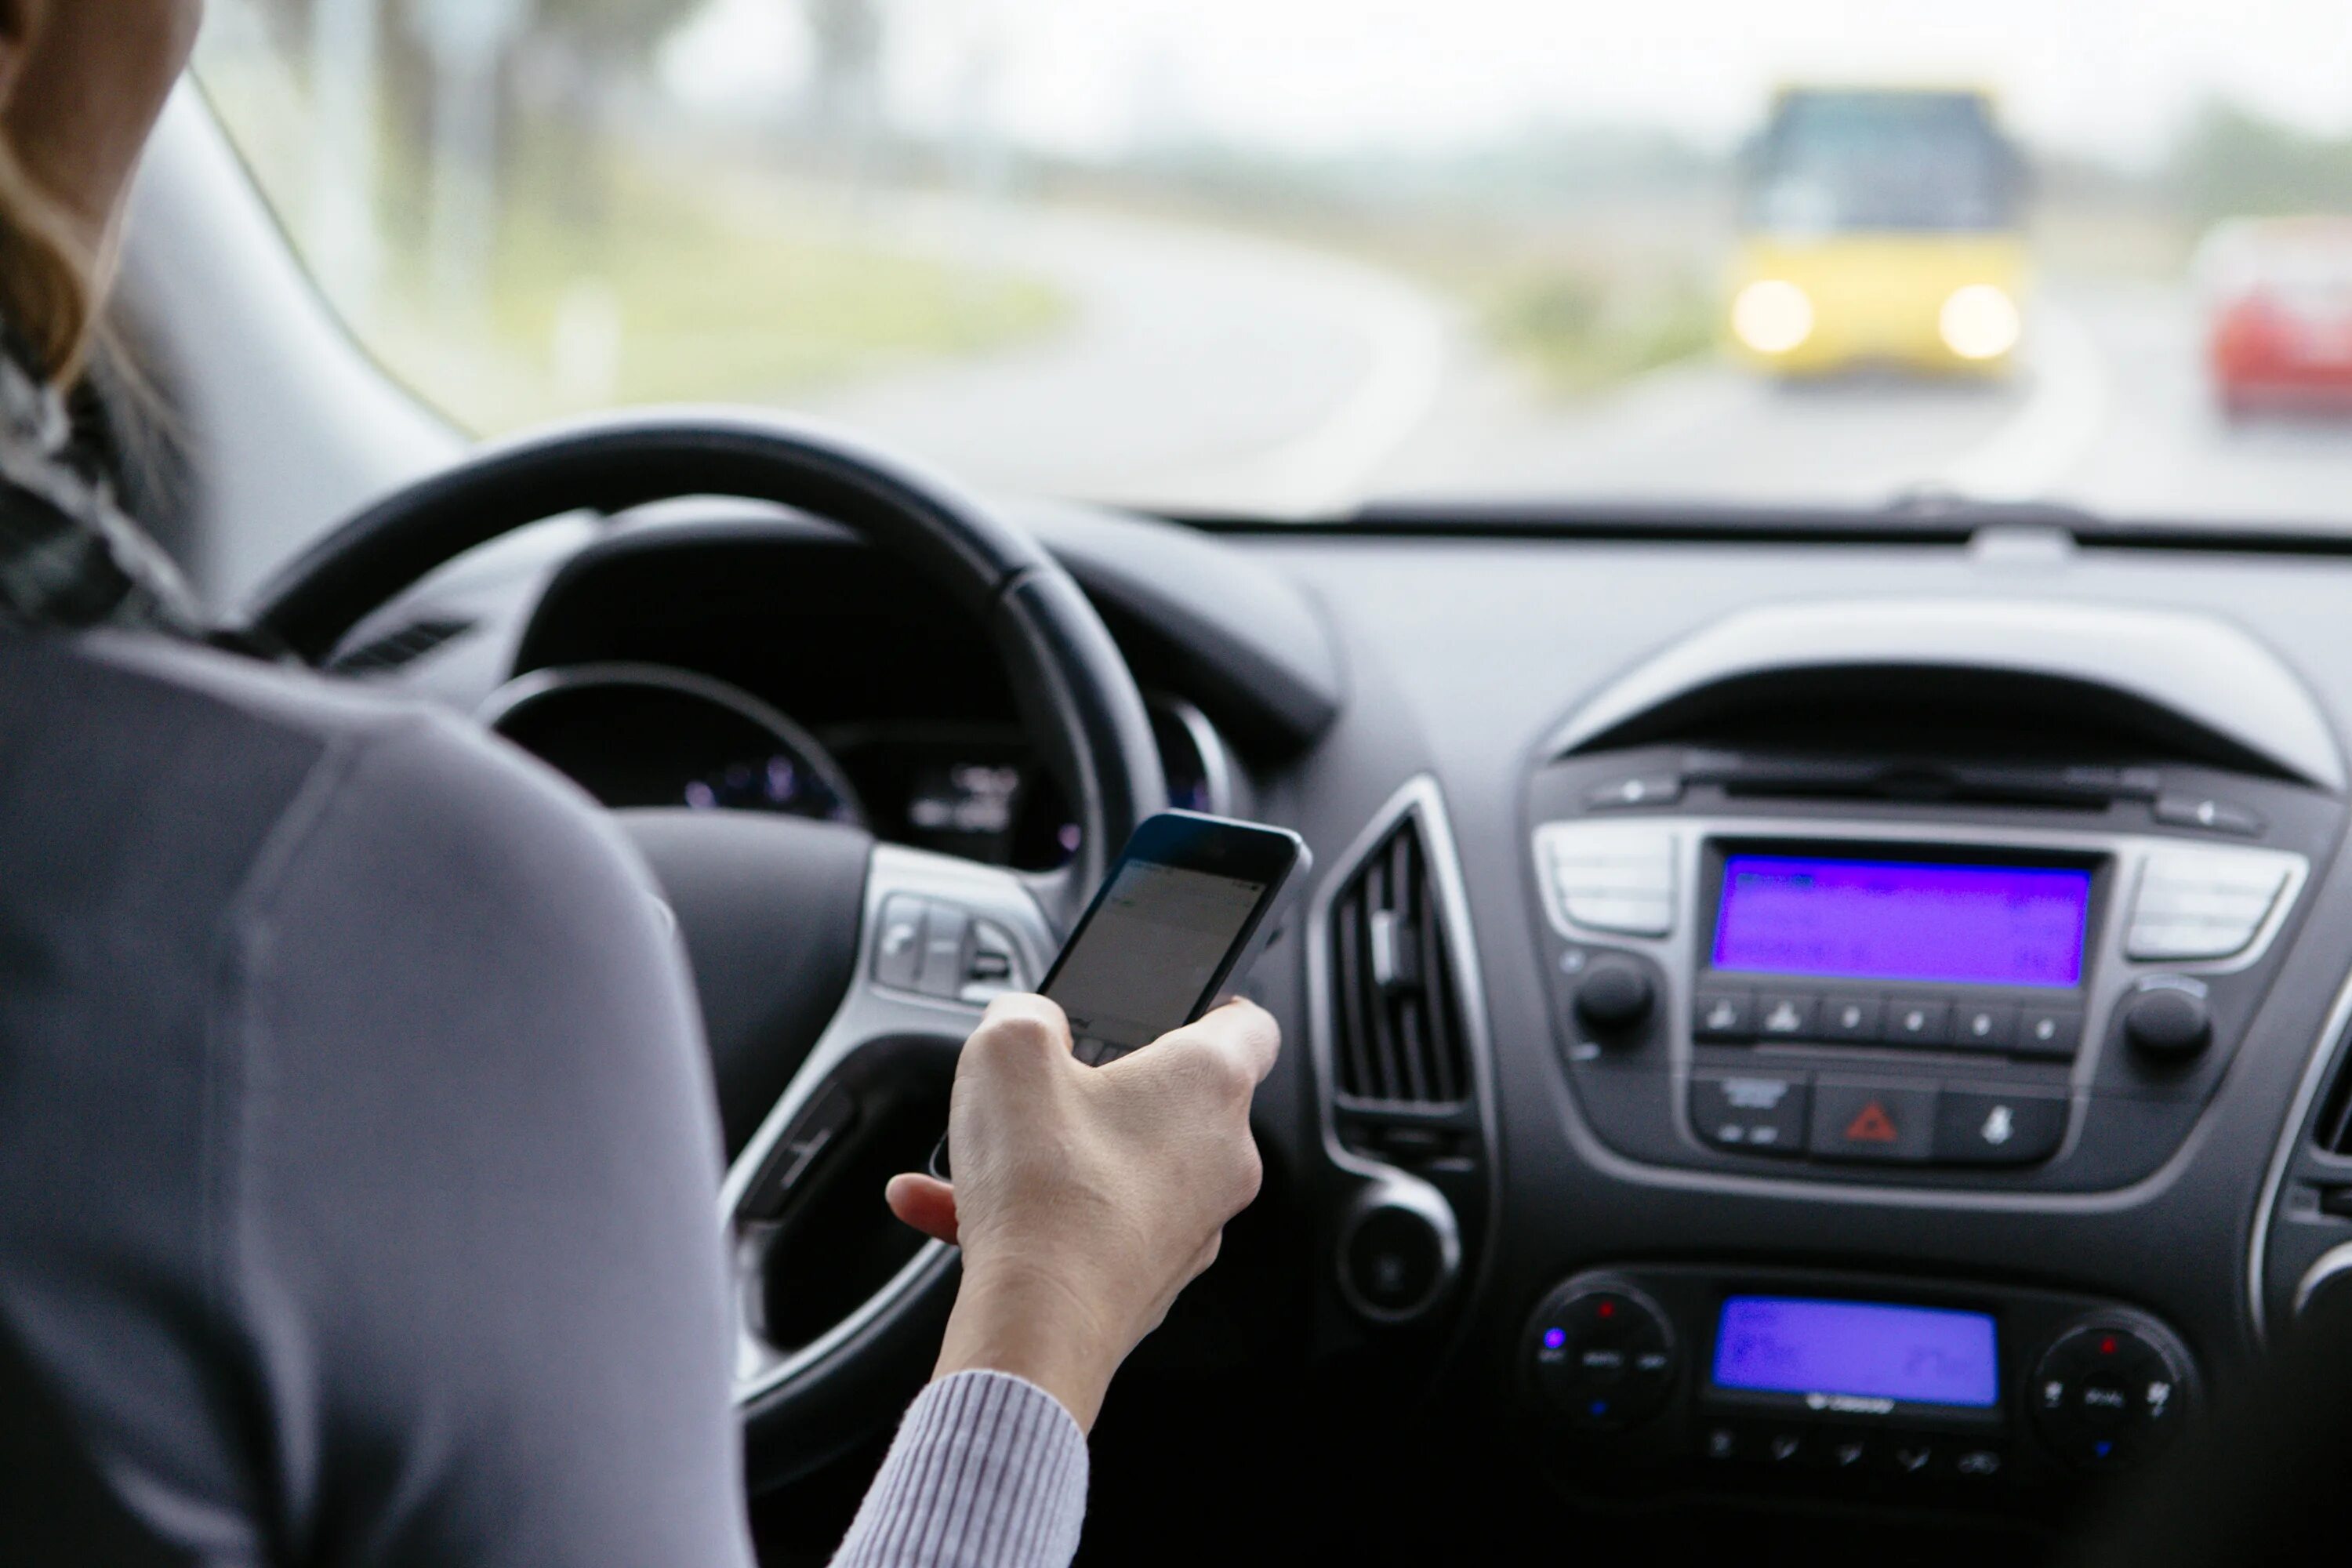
[445, 524, 1244, 869]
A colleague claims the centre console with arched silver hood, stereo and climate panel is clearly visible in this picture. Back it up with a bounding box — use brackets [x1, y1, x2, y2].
[1498, 604, 2352, 1512]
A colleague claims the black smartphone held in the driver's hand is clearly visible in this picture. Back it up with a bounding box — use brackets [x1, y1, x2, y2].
[931, 811, 1315, 1178]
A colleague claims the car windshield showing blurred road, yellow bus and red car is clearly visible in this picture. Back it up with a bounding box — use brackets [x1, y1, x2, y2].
[198, 0, 2352, 524]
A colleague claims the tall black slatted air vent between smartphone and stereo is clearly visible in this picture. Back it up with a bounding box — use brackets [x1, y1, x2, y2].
[1329, 815, 1472, 1109]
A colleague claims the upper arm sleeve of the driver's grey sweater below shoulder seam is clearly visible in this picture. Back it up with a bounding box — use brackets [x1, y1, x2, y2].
[212, 717, 750, 1568]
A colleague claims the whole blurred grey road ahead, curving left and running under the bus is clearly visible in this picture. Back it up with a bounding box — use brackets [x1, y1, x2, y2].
[800, 205, 2352, 524]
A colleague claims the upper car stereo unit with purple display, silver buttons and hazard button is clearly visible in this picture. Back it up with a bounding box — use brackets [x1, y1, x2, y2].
[1531, 757, 2310, 1192]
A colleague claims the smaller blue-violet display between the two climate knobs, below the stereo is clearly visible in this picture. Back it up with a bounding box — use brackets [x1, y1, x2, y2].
[1715, 1295, 2002, 1410]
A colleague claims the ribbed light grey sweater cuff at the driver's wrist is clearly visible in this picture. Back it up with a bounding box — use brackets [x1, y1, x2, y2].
[833, 1370, 1087, 1568]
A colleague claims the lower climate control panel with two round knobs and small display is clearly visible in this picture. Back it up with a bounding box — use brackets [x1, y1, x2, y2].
[1519, 1265, 2197, 1488]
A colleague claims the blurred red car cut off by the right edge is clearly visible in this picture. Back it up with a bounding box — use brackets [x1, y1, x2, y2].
[2199, 216, 2352, 419]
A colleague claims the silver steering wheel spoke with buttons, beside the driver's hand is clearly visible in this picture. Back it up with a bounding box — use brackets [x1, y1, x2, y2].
[720, 844, 1054, 1410]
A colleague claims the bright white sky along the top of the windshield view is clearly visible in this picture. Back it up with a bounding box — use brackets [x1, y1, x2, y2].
[666, 0, 2352, 162]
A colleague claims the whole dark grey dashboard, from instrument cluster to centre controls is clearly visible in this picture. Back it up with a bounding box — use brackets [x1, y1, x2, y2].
[336, 495, 2352, 1552]
